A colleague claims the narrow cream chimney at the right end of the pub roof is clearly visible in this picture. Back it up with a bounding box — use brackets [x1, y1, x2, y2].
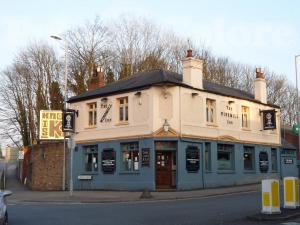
[254, 68, 267, 104]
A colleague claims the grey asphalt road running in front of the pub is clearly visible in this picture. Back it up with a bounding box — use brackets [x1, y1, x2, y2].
[8, 193, 282, 225]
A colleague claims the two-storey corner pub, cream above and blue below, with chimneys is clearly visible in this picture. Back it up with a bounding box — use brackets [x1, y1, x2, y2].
[68, 50, 281, 190]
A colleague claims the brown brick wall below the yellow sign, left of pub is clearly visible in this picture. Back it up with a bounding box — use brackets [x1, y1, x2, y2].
[23, 142, 68, 191]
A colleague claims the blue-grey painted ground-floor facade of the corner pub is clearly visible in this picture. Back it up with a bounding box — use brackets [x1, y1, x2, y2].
[73, 138, 298, 190]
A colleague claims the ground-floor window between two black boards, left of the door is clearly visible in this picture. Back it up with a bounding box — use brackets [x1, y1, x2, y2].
[121, 142, 139, 171]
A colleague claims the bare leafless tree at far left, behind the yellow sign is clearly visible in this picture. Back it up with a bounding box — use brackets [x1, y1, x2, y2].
[1, 43, 63, 146]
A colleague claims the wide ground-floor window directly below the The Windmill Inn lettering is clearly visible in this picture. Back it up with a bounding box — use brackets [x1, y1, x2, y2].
[218, 144, 234, 170]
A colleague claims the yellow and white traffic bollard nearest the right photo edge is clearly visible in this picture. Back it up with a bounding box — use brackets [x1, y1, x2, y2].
[283, 177, 299, 209]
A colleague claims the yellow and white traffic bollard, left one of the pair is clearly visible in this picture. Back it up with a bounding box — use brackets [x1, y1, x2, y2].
[261, 179, 281, 214]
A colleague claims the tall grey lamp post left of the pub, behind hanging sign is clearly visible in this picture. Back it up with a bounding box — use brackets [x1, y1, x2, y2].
[50, 35, 68, 191]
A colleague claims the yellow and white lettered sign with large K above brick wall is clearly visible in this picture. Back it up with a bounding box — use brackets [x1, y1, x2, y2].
[40, 110, 64, 140]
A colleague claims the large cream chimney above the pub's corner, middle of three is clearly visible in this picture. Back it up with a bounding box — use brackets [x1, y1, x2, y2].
[182, 49, 203, 89]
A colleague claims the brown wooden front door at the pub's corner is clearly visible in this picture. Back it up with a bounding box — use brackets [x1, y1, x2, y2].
[156, 151, 173, 188]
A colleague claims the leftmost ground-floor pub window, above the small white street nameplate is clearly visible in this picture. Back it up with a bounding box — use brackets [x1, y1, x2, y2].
[84, 145, 98, 172]
